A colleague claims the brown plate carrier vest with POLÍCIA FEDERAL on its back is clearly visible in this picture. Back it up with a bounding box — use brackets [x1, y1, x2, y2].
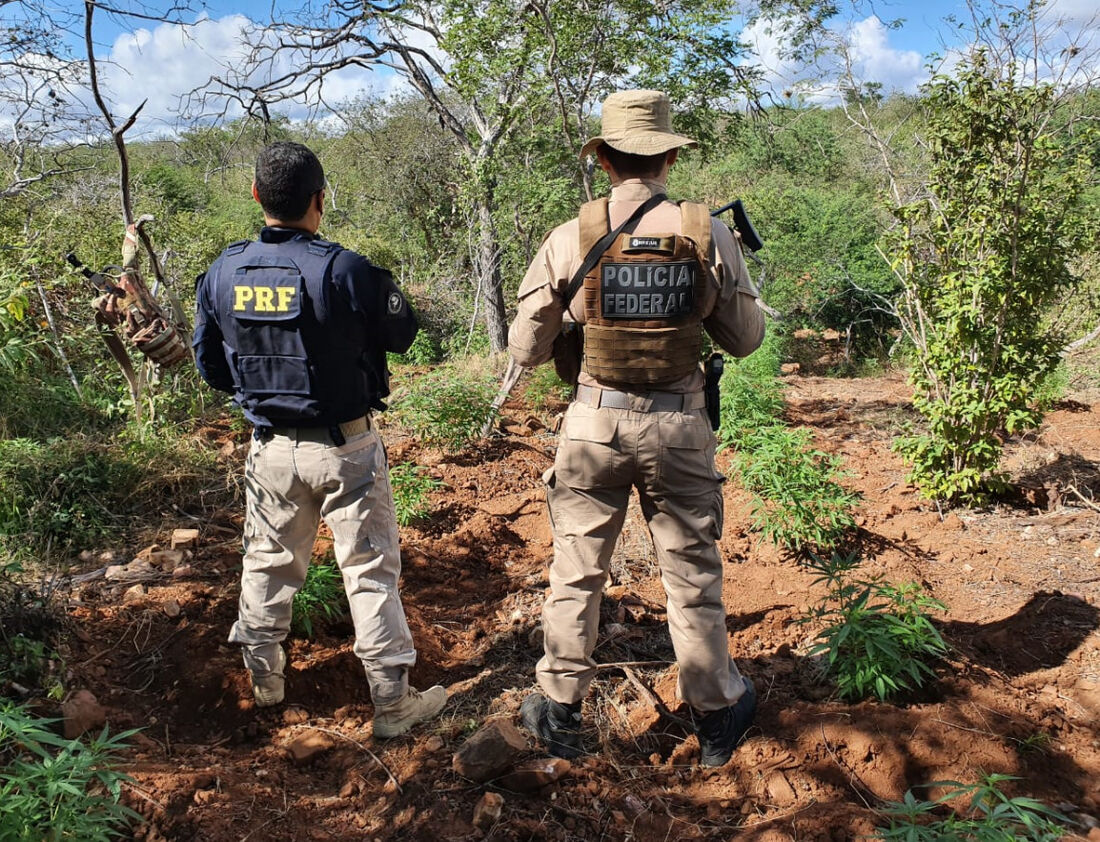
[579, 198, 711, 389]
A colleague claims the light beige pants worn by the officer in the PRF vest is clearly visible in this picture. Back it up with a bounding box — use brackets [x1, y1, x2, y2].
[229, 428, 416, 706]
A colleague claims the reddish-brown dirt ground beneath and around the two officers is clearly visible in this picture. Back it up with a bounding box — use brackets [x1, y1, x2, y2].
[58, 376, 1100, 842]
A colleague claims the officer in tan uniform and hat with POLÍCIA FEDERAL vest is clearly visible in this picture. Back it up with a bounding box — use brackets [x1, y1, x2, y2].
[508, 90, 765, 766]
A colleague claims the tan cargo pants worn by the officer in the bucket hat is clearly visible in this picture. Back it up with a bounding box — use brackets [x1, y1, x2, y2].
[536, 402, 745, 711]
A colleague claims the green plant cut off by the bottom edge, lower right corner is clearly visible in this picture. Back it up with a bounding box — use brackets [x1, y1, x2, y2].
[875, 773, 1065, 842]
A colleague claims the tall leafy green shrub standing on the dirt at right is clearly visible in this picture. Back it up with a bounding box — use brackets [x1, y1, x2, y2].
[888, 50, 1096, 503]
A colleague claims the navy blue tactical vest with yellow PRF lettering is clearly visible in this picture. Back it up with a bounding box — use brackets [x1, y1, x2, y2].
[212, 236, 384, 427]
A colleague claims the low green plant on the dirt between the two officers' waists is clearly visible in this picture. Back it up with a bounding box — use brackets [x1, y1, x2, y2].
[394, 365, 496, 450]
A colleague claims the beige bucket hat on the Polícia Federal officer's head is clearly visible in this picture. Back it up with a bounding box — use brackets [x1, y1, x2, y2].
[581, 90, 699, 158]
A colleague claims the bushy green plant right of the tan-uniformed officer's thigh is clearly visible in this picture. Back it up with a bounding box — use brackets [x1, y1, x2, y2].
[735, 426, 859, 551]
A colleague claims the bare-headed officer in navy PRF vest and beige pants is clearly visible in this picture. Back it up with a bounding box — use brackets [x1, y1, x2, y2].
[195, 142, 447, 737]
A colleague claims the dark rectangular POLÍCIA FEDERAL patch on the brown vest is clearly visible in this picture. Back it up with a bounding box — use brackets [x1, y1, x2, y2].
[600, 261, 696, 319]
